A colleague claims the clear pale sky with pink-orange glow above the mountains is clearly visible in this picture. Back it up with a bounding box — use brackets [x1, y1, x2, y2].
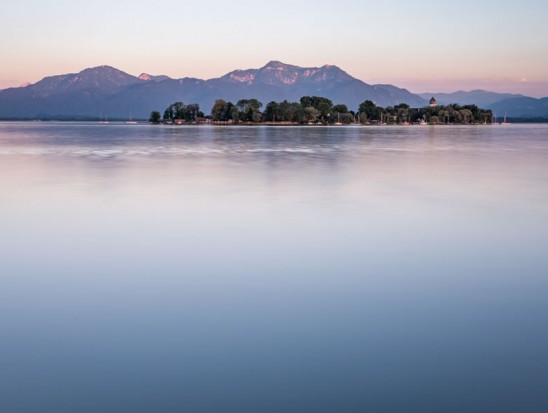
[0, 0, 548, 97]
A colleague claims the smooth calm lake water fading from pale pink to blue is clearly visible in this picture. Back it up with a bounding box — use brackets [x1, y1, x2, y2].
[0, 123, 548, 413]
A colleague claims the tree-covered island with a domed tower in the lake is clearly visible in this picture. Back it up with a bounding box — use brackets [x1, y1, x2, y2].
[149, 96, 496, 125]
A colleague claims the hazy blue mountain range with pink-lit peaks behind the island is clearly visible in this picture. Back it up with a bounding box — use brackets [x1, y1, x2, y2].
[0, 61, 548, 119]
